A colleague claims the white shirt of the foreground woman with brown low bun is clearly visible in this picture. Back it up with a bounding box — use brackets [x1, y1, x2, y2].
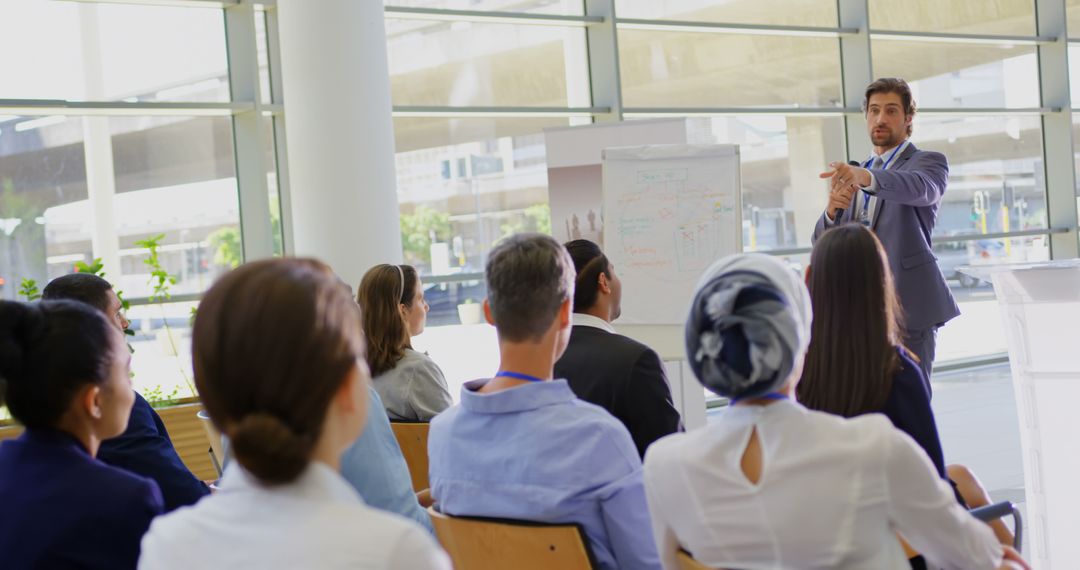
[138, 462, 450, 570]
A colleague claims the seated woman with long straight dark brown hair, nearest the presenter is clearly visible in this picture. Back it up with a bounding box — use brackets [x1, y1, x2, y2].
[798, 223, 1013, 544]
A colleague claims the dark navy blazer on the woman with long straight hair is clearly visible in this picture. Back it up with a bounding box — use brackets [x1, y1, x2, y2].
[881, 349, 945, 477]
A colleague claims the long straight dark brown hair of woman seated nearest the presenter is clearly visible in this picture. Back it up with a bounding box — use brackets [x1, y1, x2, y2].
[798, 223, 901, 417]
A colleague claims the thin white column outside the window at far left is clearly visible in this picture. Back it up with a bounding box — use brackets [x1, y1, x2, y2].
[79, 5, 121, 282]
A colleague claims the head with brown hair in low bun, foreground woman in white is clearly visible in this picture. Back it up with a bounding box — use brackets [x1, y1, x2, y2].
[192, 259, 366, 485]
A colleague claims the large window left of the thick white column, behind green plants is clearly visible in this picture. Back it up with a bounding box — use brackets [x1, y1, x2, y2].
[0, 0, 282, 399]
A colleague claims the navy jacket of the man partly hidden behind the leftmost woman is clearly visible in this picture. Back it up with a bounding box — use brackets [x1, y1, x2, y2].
[97, 392, 210, 512]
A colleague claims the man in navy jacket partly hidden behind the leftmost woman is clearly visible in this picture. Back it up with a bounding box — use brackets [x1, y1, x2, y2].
[41, 273, 210, 512]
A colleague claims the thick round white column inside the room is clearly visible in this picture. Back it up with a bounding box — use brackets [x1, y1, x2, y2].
[278, 0, 402, 289]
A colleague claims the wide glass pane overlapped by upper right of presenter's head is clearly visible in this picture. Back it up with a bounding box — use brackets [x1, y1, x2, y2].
[860, 40, 1039, 108]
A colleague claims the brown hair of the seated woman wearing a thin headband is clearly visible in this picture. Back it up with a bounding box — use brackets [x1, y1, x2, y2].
[356, 263, 419, 376]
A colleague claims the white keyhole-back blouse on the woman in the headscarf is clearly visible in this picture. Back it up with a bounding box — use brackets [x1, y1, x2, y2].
[645, 401, 1002, 570]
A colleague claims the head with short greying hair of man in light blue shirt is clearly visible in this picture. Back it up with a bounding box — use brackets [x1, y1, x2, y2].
[484, 233, 575, 342]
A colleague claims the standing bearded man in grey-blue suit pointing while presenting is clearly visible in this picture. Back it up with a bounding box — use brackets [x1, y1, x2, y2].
[812, 78, 960, 391]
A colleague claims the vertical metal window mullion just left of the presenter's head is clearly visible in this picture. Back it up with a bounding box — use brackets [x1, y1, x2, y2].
[836, 0, 874, 163]
